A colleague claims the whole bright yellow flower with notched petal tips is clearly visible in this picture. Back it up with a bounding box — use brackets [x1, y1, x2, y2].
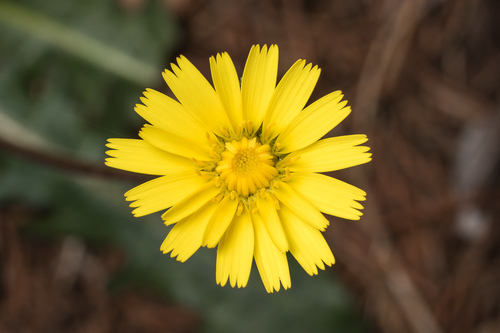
[106, 45, 371, 292]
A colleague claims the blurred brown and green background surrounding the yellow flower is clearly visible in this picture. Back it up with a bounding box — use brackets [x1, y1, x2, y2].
[0, 0, 500, 333]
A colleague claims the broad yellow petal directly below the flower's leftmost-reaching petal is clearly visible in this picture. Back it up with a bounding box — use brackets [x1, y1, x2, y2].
[125, 170, 207, 217]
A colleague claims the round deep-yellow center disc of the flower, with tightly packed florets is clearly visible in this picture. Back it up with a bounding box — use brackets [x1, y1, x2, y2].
[215, 137, 278, 196]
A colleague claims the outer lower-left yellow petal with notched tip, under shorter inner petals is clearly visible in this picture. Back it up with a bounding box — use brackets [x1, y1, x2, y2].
[160, 202, 217, 262]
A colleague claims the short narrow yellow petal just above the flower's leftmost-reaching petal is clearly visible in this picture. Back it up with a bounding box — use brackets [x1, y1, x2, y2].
[139, 125, 210, 161]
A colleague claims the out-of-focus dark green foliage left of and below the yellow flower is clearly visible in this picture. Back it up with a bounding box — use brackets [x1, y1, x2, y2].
[0, 0, 363, 333]
